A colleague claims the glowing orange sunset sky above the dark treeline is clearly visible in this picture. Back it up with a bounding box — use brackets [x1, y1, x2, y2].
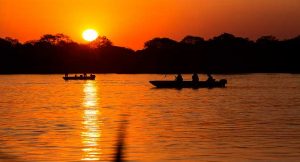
[0, 0, 300, 49]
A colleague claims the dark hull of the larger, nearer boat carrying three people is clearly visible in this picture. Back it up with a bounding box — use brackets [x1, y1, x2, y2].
[149, 79, 227, 88]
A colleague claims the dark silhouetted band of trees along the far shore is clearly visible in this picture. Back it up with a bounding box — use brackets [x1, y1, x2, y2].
[0, 33, 300, 74]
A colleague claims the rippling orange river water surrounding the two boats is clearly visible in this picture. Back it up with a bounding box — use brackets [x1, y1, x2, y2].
[0, 74, 300, 162]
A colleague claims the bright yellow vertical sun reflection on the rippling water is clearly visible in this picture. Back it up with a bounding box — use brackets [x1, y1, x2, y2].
[81, 81, 101, 161]
